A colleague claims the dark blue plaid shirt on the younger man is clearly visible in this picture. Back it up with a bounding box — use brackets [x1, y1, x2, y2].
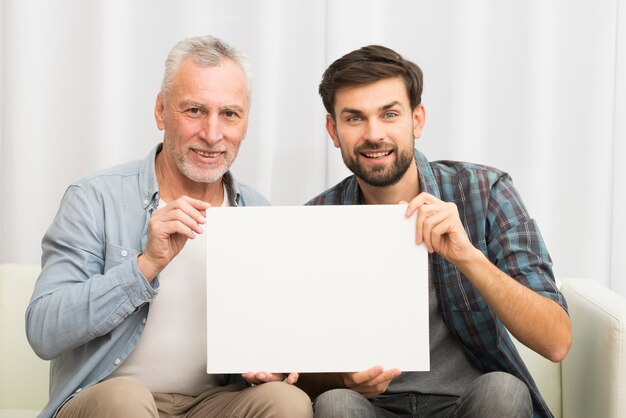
[307, 150, 567, 417]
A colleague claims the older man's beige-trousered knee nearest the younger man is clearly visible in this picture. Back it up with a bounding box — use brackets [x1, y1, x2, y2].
[254, 382, 313, 418]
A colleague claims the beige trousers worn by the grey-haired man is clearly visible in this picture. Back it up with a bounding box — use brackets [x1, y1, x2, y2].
[57, 377, 313, 418]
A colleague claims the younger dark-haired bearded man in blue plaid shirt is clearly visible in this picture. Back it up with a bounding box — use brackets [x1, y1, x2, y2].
[298, 46, 572, 418]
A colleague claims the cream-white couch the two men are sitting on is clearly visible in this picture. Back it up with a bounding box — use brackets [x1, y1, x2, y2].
[0, 264, 626, 418]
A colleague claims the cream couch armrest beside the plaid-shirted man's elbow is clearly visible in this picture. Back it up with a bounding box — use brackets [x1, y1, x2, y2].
[561, 278, 626, 418]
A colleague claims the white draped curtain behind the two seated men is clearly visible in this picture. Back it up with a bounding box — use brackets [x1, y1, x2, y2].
[0, 0, 626, 296]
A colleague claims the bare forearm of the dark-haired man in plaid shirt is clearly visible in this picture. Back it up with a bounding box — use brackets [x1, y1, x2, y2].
[455, 250, 572, 362]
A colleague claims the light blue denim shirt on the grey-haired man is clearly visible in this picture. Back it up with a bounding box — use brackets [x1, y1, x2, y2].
[26, 144, 269, 418]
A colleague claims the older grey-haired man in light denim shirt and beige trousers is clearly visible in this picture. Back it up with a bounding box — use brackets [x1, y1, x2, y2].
[26, 36, 312, 418]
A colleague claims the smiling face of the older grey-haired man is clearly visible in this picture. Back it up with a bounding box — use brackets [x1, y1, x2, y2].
[155, 59, 249, 183]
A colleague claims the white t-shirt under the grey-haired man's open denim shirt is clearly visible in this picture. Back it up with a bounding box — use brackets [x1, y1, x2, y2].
[109, 189, 229, 396]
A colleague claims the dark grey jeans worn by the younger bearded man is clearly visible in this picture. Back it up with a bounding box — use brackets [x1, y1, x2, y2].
[313, 372, 533, 418]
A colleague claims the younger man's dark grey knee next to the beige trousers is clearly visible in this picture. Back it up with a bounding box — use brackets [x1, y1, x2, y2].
[313, 389, 371, 418]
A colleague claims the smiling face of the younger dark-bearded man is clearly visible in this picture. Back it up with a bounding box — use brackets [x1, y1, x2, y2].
[326, 77, 425, 187]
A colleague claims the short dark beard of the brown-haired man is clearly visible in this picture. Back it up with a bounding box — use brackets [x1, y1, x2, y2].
[343, 143, 414, 187]
